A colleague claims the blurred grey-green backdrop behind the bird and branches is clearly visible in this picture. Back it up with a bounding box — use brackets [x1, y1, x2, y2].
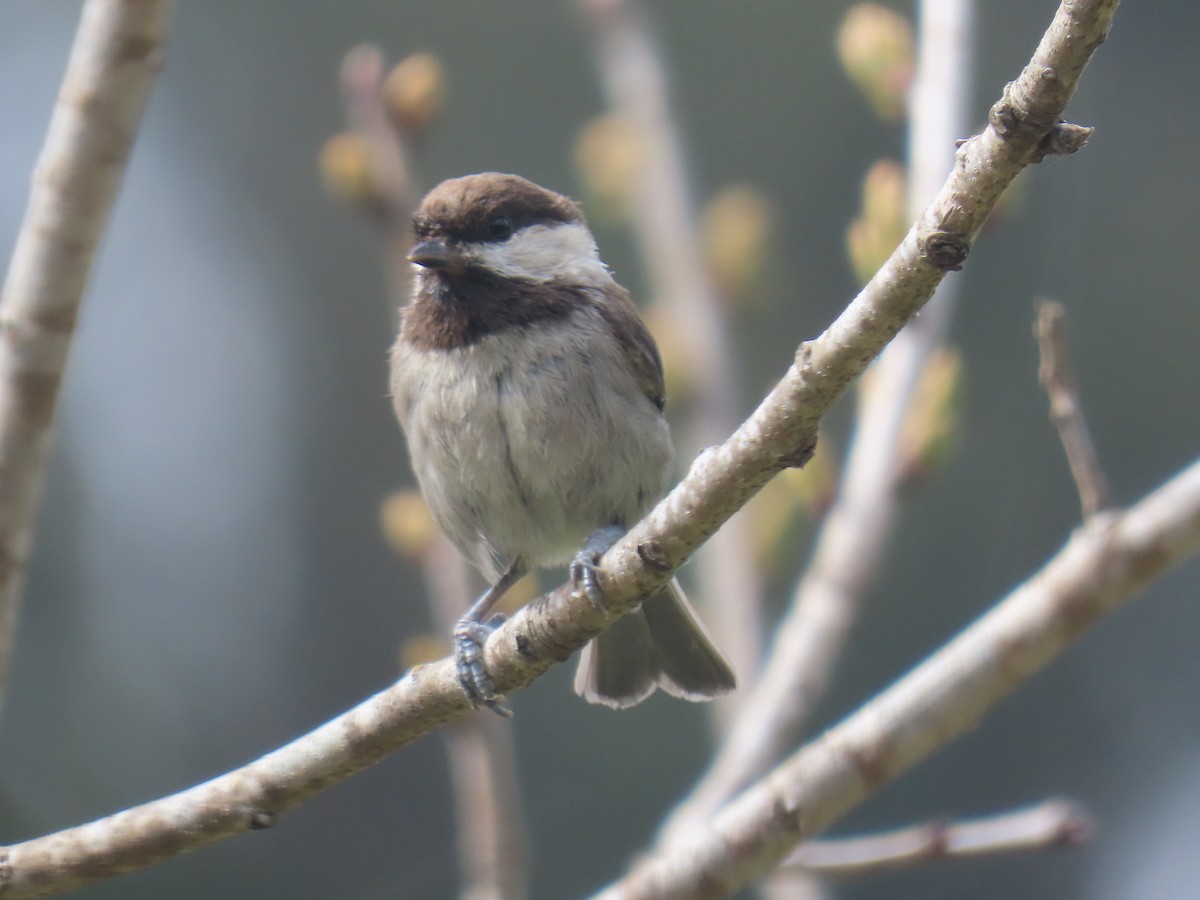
[0, 0, 1200, 900]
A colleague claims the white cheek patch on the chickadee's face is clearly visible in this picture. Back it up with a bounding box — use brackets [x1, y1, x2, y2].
[472, 222, 610, 287]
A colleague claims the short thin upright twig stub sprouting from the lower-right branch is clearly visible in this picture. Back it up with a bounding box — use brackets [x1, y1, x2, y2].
[1033, 300, 1110, 521]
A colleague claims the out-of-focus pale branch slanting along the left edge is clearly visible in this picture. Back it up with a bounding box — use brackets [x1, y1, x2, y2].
[0, 0, 170, 710]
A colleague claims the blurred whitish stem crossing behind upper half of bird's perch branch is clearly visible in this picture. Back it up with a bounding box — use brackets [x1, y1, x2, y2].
[660, 0, 972, 844]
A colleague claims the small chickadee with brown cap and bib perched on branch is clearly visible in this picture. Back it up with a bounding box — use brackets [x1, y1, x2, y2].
[391, 173, 736, 714]
